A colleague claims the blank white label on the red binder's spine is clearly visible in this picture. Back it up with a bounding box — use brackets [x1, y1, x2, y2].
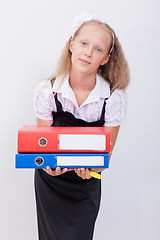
[59, 134, 106, 151]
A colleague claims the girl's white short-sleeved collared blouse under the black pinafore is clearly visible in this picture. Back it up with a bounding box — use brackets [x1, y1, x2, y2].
[33, 75, 127, 126]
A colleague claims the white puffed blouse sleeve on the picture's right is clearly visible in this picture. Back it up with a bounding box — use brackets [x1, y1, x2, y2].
[104, 89, 127, 127]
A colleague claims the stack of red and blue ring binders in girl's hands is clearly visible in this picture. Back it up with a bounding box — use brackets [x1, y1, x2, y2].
[15, 126, 110, 168]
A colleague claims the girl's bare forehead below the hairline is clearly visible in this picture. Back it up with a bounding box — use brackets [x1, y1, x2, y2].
[77, 23, 111, 43]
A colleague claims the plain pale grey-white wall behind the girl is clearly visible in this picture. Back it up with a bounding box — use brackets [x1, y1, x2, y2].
[0, 0, 160, 240]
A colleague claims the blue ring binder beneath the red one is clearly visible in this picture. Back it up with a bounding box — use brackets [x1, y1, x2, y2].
[15, 153, 109, 168]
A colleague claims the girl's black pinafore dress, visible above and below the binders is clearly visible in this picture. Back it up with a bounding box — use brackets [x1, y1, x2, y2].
[35, 89, 106, 240]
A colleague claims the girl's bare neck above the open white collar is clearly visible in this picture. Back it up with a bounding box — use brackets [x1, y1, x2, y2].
[69, 69, 96, 91]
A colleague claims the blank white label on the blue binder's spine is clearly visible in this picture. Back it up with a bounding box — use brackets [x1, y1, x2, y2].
[57, 156, 104, 166]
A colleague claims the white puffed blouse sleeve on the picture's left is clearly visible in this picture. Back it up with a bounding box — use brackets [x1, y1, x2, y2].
[33, 80, 56, 120]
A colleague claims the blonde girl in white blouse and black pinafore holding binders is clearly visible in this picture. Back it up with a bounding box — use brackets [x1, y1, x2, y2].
[34, 15, 129, 240]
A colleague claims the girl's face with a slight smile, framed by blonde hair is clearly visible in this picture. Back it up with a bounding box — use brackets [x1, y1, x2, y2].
[70, 24, 111, 74]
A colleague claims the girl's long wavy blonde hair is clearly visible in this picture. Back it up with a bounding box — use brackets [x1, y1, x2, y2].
[52, 20, 130, 91]
